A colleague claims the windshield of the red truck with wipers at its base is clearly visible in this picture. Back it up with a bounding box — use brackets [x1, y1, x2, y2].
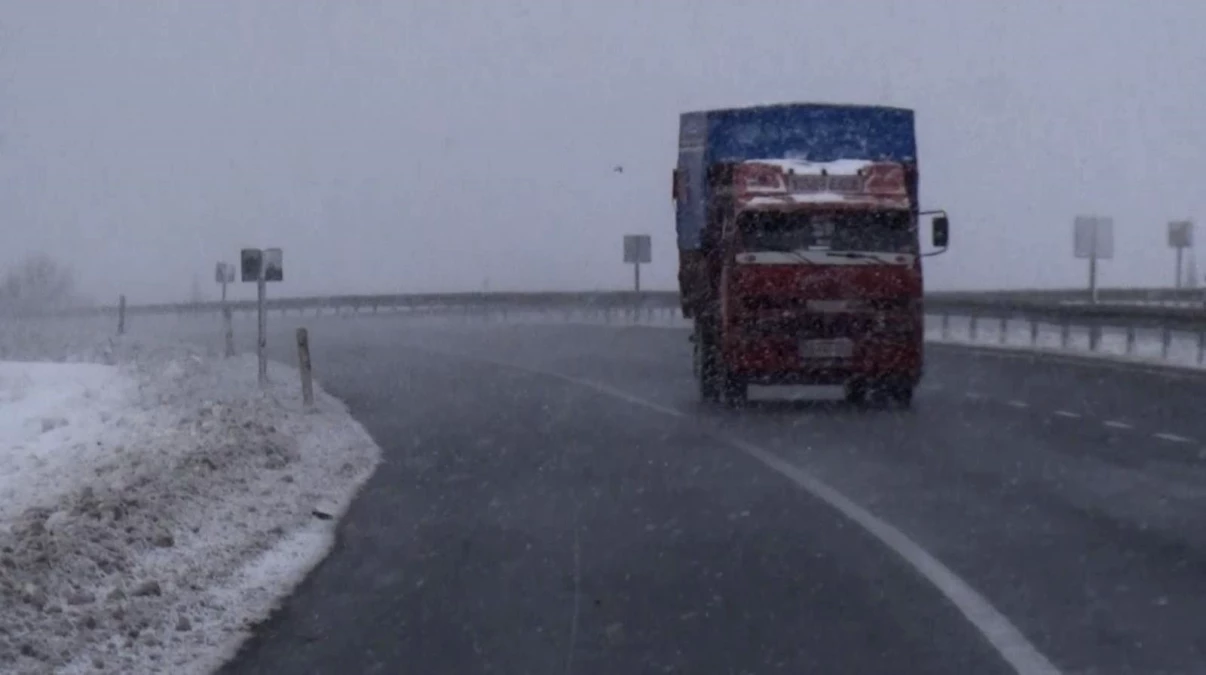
[737, 211, 918, 253]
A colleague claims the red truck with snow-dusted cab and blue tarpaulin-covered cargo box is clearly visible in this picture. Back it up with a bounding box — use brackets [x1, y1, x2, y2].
[673, 104, 947, 403]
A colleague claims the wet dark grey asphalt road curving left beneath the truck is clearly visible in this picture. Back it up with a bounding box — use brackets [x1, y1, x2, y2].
[226, 317, 1206, 674]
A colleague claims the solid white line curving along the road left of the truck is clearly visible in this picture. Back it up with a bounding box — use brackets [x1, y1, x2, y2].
[428, 350, 1060, 675]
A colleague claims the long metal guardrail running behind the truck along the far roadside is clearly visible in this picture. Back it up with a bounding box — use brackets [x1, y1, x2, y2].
[7, 288, 1206, 364]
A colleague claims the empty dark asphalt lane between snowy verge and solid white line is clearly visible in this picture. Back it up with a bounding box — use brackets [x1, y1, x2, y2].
[217, 318, 1009, 674]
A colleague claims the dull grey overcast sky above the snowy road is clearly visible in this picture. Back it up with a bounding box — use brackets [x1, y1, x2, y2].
[0, 0, 1206, 300]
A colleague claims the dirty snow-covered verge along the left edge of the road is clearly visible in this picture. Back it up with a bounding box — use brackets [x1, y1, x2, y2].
[0, 345, 380, 674]
